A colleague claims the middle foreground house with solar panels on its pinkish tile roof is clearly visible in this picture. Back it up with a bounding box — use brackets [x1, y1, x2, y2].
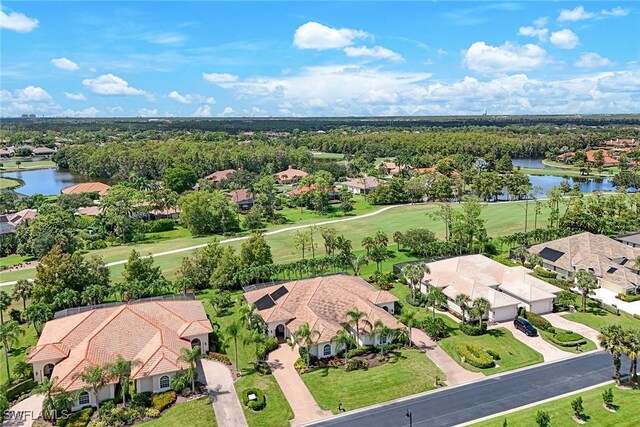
[244, 274, 404, 358]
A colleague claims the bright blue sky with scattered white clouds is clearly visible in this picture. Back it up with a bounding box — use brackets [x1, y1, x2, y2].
[0, 1, 640, 117]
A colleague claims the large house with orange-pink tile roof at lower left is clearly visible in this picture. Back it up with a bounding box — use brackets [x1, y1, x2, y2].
[27, 300, 213, 411]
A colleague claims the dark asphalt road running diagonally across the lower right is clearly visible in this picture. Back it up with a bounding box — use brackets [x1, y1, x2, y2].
[313, 352, 629, 427]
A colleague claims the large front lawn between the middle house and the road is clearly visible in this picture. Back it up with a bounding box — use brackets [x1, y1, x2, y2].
[302, 350, 444, 413]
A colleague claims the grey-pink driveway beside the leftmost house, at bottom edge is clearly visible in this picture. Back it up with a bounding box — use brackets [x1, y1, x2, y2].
[200, 359, 247, 427]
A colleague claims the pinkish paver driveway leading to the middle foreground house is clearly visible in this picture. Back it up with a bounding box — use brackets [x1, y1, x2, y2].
[267, 344, 338, 425]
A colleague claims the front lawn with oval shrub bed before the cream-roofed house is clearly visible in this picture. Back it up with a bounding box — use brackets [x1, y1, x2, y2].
[438, 328, 543, 375]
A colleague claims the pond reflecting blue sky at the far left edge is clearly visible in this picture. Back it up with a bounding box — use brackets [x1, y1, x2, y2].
[1, 169, 109, 196]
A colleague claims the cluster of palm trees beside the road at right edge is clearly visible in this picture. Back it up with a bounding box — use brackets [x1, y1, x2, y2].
[598, 325, 640, 386]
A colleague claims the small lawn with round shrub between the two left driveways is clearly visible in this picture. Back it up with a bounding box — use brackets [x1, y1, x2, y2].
[235, 373, 293, 427]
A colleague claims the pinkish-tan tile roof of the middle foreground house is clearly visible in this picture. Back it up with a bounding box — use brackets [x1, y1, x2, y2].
[244, 274, 404, 342]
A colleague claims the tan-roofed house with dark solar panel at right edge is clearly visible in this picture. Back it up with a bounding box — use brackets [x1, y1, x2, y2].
[529, 232, 640, 293]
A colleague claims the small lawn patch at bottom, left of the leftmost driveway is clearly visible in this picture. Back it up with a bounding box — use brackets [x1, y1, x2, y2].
[139, 397, 218, 427]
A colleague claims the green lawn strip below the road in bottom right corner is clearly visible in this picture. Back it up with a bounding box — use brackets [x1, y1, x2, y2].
[473, 384, 640, 427]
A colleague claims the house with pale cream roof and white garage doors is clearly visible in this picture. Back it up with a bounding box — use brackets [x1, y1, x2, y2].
[420, 255, 562, 322]
